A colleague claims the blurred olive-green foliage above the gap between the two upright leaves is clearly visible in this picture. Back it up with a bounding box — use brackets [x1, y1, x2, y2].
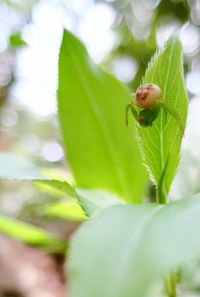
[102, 0, 191, 88]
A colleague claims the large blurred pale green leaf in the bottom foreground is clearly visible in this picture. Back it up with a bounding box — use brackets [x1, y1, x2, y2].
[68, 195, 200, 297]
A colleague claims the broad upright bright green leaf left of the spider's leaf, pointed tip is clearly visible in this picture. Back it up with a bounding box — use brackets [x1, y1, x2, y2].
[58, 30, 146, 202]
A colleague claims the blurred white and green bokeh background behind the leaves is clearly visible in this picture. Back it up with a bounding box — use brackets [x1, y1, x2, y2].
[0, 0, 200, 297]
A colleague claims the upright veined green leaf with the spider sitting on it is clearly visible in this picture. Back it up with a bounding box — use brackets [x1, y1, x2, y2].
[137, 37, 187, 200]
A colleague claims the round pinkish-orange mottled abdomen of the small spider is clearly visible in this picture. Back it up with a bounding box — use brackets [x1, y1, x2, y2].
[135, 84, 162, 109]
